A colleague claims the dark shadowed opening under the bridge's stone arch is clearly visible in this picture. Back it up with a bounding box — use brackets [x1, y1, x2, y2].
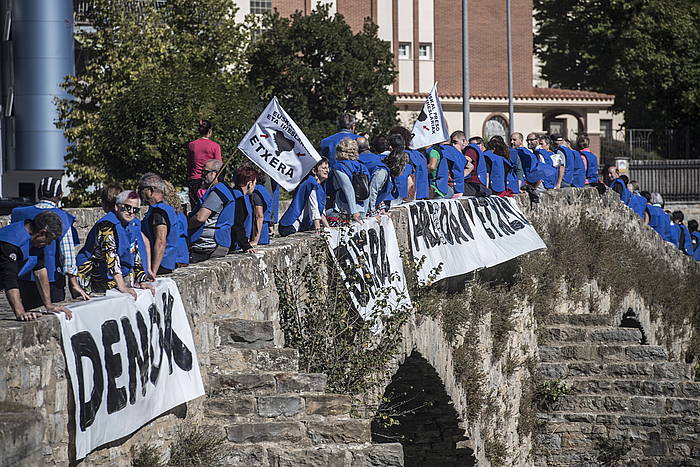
[372, 351, 476, 467]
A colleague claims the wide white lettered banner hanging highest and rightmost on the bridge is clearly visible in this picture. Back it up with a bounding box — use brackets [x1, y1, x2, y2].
[406, 196, 547, 282]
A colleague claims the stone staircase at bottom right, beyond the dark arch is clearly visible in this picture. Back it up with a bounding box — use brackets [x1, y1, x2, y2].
[537, 314, 700, 467]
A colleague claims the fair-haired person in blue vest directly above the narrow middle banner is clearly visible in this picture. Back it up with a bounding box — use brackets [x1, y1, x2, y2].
[332, 138, 369, 222]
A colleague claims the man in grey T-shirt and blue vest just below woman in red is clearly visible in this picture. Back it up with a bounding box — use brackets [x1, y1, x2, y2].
[187, 159, 234, 263]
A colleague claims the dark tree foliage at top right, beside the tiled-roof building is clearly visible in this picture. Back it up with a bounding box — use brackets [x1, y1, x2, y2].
[534, 0, 700, 129]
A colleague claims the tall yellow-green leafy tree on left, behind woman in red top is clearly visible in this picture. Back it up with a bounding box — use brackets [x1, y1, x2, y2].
[59, 0, 257, 205]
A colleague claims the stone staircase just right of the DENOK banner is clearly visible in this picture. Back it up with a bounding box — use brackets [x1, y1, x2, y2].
[205, 319, 403, 467]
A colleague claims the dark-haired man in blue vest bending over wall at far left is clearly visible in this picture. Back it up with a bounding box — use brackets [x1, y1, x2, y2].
[0, 209, 71, 321]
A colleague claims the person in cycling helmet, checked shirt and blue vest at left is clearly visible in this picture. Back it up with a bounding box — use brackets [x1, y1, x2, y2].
[10, 177, 90, 306]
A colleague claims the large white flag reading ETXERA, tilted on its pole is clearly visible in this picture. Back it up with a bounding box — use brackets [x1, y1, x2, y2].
[238, 97, 321, 191]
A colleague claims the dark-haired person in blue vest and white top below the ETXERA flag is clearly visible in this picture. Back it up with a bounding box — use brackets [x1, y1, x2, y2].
[279, 159, 330, 237]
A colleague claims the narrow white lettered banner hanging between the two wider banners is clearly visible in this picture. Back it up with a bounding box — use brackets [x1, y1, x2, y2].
[329, 216, 411, 320]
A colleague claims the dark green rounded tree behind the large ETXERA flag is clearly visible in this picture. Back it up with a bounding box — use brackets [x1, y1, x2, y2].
[248, 6, 396, 142]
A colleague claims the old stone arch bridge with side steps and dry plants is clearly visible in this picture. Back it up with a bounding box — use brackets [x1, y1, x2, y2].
[0, 190, 700, 466]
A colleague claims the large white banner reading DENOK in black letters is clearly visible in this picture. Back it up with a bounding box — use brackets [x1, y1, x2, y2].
[59, 279, 204, 459]
